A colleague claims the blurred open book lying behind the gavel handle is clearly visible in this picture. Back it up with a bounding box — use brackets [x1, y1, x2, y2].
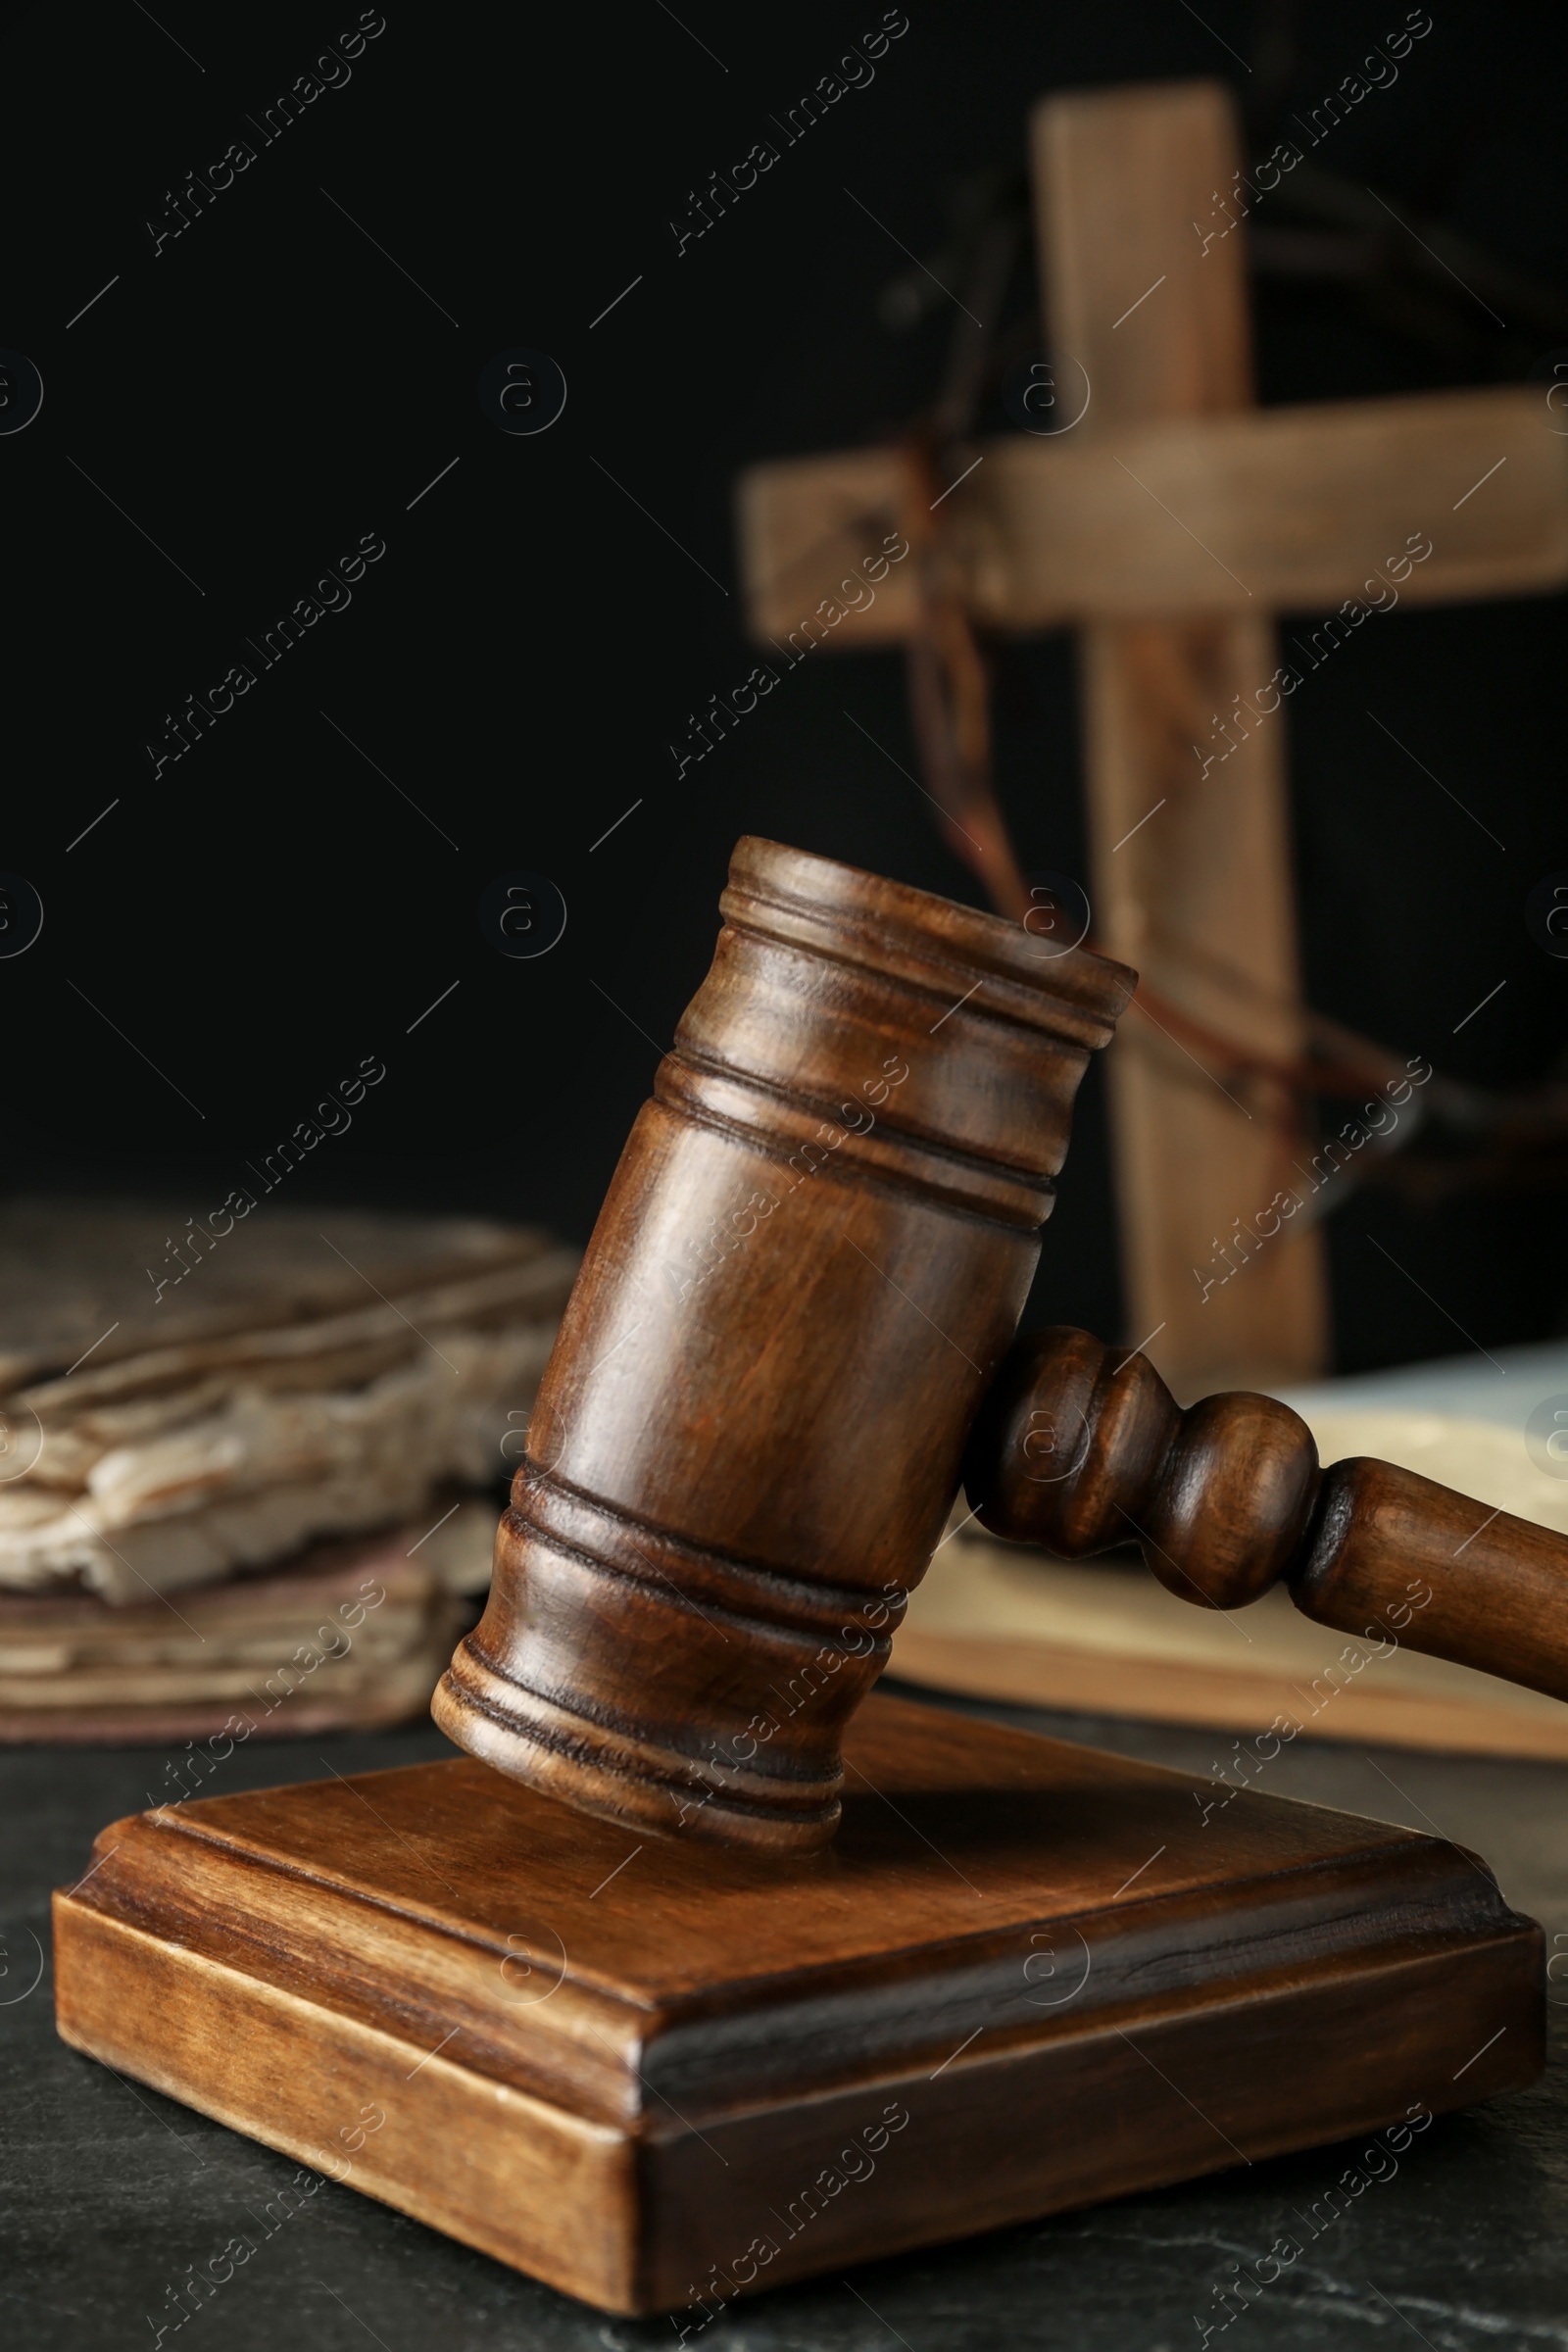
[891, 1343, 1568, 1757]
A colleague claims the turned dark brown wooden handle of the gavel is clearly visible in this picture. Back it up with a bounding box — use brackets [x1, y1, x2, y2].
[964, 1327, 1568, 1698]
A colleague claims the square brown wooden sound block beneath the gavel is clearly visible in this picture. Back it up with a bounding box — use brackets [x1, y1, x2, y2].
[54, 1695, 1544, 2333]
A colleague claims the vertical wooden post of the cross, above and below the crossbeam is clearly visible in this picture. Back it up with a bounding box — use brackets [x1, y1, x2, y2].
[1032, 82, 1328, 1395]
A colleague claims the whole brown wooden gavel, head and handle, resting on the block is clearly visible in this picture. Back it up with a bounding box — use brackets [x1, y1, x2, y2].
[432, 840, 1568, 1853]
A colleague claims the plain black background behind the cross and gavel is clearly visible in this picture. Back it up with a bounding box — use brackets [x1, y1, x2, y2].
[0, 0, 1568, 1364]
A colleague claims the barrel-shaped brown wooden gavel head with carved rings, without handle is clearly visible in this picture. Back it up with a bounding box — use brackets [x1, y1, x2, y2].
[432, 840, 1133, 1853]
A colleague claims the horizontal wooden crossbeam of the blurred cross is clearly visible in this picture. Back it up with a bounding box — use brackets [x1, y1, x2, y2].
[741, 388, 1568, 649]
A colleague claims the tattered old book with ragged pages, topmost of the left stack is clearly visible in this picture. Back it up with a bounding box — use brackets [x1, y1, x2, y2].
[0, 1204, 576, 1606]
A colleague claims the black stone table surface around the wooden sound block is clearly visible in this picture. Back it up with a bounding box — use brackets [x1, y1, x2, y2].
[0, 1691, 1568, 2352]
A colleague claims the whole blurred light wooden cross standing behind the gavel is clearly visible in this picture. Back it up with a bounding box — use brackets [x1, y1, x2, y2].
[741, 82, 1568, 1395]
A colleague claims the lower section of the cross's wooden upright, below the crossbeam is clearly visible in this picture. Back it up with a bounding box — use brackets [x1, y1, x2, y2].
[1079, 618, 1328, 1397]
